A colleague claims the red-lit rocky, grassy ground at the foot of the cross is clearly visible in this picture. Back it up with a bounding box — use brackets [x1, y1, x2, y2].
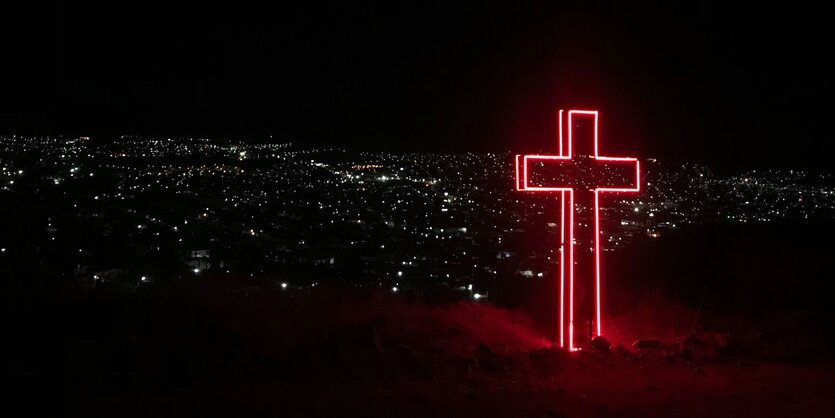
[6, 282, 835, 417]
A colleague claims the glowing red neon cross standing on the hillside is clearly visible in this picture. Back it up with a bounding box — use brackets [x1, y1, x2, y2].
[516, 110, 641, 350]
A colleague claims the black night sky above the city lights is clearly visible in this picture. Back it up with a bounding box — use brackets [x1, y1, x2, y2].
[0, 1, 835, 170]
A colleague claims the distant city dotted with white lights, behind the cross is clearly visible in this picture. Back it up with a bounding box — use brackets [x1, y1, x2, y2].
[0, 135, 835, 295]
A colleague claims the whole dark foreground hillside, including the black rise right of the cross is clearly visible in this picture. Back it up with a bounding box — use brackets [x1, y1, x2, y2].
[2, 220, 835, 417]
